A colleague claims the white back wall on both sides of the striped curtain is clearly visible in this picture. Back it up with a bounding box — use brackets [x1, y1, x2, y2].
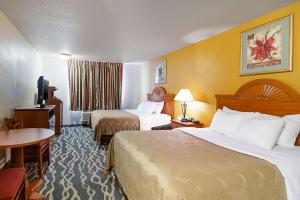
[42, 55, 150, 125]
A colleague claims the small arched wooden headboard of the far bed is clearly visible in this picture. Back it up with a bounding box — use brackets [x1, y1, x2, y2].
[147, 86, 174, 118]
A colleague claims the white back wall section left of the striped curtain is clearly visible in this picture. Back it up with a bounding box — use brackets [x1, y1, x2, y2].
[42, 55, 81, 125]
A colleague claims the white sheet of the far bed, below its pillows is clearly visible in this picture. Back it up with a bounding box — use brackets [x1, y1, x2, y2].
[126, 110, 171, 131]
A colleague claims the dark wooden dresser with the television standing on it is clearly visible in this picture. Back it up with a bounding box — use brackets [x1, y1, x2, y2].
[15, 105, 56, 134]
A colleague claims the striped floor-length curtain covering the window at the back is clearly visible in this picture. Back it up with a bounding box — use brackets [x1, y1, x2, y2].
[68, 60, 123, 111]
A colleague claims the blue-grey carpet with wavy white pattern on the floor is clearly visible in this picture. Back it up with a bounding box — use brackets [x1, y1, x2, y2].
[27, 127, 125, 200]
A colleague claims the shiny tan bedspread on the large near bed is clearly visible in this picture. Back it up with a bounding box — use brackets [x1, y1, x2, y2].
[107, 130, 287, 200]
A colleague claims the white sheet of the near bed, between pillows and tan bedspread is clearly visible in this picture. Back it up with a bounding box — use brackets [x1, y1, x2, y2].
[177, 128, 300, 200]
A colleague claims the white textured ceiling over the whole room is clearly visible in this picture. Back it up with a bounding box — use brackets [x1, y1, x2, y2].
[0, 0, 294, 62]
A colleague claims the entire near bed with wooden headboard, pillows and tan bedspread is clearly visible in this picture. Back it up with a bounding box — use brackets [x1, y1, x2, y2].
[107, 79, 300, 200]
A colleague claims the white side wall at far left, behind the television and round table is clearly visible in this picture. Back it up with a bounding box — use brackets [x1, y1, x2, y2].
[0, 11, 41, 165]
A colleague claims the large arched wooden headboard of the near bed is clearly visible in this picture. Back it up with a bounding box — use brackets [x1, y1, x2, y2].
[216, 79, 300, 146]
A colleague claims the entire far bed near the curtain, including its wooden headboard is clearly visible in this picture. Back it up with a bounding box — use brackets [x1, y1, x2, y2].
[91, 87, 174, 144]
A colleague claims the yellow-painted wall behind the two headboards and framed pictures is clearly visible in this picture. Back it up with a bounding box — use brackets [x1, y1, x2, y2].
[150, 2, 300, 126]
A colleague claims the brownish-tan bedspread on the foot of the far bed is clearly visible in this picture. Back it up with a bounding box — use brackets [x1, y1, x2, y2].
[91, 110, 140, 143]
